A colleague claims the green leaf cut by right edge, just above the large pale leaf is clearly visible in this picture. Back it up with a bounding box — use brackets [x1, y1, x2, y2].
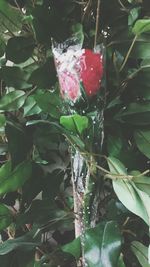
[134, 129, 150, 159]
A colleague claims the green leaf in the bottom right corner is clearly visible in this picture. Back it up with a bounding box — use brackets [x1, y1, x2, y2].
[131, 241, 150, 267]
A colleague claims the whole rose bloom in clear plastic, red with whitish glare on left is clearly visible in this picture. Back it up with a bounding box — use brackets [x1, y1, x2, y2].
[55, 49, 103, 102]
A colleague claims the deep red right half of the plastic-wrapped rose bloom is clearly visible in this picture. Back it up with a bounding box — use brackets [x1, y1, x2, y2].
[80, 49, 103, 96]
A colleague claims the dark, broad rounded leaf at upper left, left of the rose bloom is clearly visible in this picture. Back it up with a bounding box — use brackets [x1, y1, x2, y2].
[6, 36, 35, 64]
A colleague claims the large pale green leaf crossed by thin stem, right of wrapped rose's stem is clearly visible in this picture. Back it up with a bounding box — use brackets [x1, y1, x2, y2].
[108, 157, 150, 225]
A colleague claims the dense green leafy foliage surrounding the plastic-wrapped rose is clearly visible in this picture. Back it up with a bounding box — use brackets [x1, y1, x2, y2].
[0, 0, 150, 267]
